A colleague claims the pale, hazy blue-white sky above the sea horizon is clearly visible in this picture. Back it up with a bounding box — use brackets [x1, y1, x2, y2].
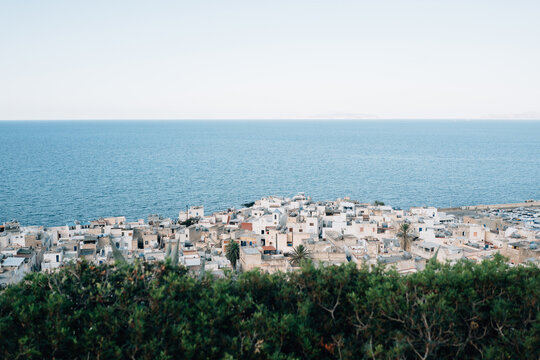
[0, 0, 540, 120]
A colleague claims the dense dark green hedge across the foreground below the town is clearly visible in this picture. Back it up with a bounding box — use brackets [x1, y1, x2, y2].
[0, 258, 540, 359]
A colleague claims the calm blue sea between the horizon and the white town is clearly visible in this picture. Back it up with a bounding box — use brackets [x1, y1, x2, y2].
[0, 121, 540, 225]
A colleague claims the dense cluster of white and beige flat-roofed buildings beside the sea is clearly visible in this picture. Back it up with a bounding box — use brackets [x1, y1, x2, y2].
[0, 193, 540, 286]
